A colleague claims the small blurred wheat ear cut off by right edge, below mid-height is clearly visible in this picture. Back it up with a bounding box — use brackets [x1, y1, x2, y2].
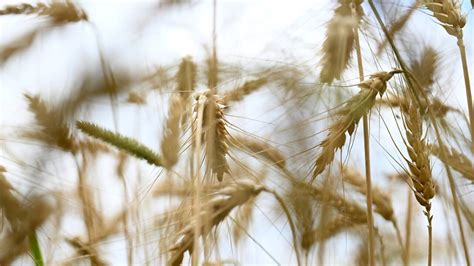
[429, 145, 474, 182]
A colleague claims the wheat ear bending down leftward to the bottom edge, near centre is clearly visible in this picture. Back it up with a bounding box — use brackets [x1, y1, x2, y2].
[168, 180, 264, 266]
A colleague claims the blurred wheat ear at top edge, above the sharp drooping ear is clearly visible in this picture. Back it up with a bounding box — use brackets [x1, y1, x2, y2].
[320, 0, 364, 83]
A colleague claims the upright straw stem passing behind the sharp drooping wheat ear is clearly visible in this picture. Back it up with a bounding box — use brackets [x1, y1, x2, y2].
[354, 5, 375, 266]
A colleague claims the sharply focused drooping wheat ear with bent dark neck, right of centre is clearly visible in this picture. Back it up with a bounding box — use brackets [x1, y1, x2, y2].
[312, 69, 402, 181]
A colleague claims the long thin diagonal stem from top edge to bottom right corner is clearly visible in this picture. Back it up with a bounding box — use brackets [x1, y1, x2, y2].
[369, 0, 471, 265]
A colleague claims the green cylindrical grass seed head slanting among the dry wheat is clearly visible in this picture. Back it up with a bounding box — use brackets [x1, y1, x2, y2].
[76, 121, 163, 166]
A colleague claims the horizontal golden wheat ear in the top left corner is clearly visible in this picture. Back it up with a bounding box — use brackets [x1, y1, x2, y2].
[0, 1, 87, 23]
